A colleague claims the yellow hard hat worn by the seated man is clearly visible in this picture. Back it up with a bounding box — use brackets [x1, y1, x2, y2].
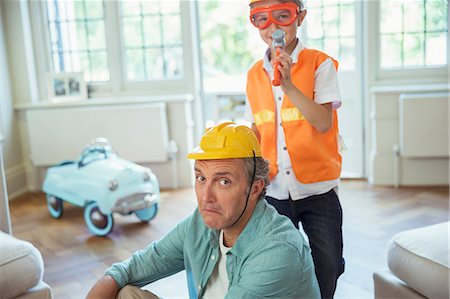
[187, 122, 261, 160]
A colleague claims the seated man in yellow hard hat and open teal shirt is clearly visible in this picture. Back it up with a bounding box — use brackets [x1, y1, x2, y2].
[87, 123, 320, 299]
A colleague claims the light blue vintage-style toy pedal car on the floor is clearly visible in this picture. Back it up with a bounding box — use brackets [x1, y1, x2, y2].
[43, 138, 160, 236]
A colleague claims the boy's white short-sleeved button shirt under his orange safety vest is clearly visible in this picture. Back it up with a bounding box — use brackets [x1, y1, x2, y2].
[245, 40, 341, 200]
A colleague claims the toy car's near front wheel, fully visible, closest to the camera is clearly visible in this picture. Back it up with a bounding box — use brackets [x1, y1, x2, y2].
[84, 202, 114, 237]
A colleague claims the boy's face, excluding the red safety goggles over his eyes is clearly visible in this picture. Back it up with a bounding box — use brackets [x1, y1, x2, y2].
[251, 0, 306, 53]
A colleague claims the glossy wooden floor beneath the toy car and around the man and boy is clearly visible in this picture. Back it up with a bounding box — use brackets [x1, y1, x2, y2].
[10, 181, 449, 299]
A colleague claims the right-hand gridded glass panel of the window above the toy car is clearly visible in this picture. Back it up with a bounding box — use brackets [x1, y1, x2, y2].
[121, 0, 184, 81]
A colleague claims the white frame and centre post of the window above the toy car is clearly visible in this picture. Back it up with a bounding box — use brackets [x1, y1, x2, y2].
[30, 1, 195, 101]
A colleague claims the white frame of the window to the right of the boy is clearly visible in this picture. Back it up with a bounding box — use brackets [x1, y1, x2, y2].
[366, 1, 450, 84]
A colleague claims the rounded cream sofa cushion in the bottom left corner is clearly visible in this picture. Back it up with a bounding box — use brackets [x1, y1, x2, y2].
[0, 231, 44, 298]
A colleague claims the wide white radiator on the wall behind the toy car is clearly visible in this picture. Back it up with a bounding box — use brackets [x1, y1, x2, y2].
[26, 103, 169, 166]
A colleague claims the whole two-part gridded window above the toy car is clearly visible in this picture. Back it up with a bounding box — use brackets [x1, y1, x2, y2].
[43, 0, 185, 89]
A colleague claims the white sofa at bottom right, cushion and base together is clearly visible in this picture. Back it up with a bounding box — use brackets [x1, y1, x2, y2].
[373, 222, 450, 299]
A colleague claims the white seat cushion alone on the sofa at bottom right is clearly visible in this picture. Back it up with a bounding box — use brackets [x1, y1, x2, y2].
[388, 222, 450, 298]
